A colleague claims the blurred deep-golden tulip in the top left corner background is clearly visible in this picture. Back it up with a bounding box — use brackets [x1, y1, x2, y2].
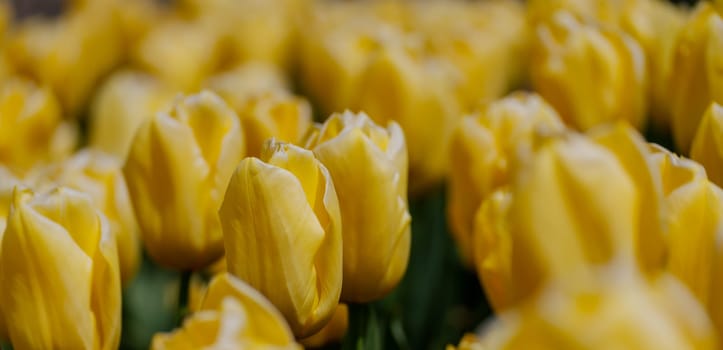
[8, 2, 122, 117]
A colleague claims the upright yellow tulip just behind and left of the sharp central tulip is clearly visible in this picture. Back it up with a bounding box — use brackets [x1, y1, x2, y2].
[123, 91, 244, 269]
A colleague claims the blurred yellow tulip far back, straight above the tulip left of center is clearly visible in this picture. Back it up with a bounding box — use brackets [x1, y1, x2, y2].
[132, 19, 221, 92]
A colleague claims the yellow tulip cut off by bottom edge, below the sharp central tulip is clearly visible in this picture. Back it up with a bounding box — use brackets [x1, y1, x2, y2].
[151, 273, 301, 350]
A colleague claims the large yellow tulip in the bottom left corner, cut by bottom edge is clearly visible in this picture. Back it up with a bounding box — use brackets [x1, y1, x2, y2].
[0, 187, 121, 350]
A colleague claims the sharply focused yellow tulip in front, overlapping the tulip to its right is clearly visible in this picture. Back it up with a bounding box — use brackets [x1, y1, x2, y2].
[219, 139, 342, 337]
